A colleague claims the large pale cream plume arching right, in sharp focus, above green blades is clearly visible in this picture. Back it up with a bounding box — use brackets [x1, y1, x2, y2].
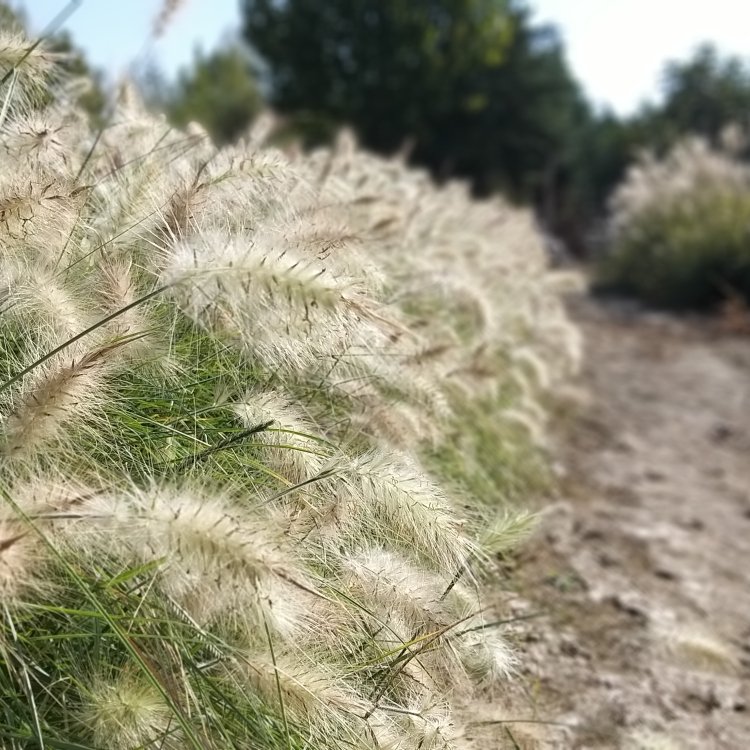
[163, 232, 390, 372]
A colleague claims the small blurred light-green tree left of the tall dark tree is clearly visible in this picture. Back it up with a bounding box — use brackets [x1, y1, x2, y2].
[163, 46, 263, 144]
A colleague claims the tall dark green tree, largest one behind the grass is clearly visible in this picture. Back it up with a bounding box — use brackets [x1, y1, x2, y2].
[242, 0, 585, 203]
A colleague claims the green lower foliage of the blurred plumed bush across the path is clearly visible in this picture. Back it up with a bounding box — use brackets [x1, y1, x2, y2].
[602, 188, 750, 309]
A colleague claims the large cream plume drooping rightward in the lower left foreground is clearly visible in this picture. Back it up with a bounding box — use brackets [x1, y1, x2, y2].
[66, 486, 305, 631]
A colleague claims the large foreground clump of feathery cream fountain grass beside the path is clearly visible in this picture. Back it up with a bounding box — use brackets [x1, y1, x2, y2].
[0, 30, 579, 750]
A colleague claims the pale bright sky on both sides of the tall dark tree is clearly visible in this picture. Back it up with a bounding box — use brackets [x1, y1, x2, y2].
[15, 0, 750, 114]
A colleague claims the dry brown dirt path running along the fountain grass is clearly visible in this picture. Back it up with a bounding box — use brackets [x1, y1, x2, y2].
[500, 301, 750, 750]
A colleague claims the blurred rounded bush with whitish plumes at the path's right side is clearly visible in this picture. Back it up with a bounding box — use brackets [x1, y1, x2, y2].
[600, 134, 750, 309]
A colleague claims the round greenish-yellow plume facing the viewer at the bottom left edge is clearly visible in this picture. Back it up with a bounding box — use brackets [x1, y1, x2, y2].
[77, 671, 185, 750]
